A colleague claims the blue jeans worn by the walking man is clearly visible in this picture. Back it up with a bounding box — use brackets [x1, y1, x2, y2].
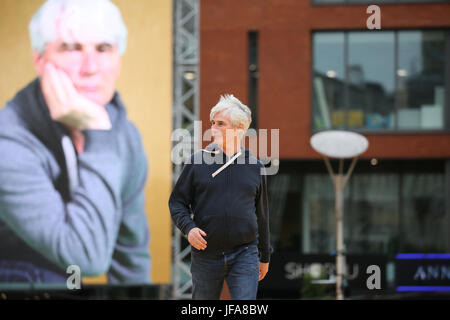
[191, 245, 259, 300]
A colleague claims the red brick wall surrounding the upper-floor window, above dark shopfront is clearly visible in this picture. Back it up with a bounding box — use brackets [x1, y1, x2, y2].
[200, 0, 450, 159]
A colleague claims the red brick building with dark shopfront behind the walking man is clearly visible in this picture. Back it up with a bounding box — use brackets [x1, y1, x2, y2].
[200, 0, 450, 298]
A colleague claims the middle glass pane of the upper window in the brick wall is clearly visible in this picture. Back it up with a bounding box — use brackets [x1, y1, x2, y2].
[346, 31, 395, 129]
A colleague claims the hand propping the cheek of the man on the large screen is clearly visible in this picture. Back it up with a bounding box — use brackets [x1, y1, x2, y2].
[41, 63, 111, 130]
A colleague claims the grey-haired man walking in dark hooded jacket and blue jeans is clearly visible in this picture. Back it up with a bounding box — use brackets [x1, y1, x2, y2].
[169, 95, 271, 300]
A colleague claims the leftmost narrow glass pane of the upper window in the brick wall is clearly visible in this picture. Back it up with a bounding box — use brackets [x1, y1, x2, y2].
[313, 32, 345, 129]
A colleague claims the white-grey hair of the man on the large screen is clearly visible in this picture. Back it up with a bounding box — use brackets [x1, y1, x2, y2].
[28, 0, 128, 55]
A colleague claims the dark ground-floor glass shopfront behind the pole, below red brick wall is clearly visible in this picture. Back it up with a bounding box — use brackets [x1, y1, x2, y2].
[268, 160, 450, 258]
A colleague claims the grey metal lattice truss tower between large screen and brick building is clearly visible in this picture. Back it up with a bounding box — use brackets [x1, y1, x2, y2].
[172, 0, 201, 299]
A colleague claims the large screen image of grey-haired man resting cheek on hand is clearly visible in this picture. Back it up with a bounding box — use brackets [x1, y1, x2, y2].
[0, 0, 150, 283]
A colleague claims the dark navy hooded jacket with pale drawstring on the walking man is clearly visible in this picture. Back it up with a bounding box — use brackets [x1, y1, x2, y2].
[169, 143, 270, 262]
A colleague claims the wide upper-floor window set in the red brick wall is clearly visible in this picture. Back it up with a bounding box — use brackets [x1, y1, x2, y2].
[312, 30, 449, 131]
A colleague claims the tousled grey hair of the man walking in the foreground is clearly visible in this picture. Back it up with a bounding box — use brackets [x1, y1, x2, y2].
[209, 94, 252, 132]
